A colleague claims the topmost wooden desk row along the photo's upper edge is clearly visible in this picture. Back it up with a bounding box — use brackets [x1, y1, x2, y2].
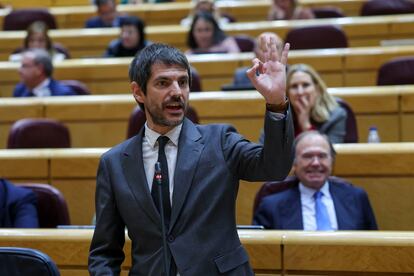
[0, 0, 366, 29]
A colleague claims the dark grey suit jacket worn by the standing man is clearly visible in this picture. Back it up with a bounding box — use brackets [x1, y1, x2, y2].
[89, 111, 293, 276]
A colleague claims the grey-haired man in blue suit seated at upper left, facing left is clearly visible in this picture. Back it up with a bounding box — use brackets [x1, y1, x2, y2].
[13, 49, 76, 97]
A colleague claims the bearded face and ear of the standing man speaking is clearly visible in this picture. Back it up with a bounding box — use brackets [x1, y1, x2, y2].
[131, 64, 190, 134]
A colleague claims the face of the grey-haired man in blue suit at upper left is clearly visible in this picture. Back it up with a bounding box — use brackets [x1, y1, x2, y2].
[19, 52, 44, 88]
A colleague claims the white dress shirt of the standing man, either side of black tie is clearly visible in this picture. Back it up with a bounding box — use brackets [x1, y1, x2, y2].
[142, 123, 183, 205]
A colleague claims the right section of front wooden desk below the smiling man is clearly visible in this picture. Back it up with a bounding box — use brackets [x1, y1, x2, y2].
[282, 231, 414, 275]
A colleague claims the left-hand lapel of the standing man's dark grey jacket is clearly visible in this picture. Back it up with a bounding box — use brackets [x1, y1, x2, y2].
[122, 128, 161, 224]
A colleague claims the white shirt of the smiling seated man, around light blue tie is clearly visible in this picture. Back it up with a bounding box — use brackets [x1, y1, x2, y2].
[299, 181, 338, 231]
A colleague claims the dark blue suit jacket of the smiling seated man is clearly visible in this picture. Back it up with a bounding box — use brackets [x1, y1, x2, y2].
[253, 177, 378, 230]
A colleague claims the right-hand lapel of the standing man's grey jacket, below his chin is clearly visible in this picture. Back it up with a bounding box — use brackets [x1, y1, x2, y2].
[170, 119, 204, 230]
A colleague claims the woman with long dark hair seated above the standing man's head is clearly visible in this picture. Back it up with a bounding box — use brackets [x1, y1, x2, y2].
[186, 12, 240, 54]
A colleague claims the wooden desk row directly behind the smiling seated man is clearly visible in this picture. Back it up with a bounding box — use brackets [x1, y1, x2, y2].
[0, 143, 414, 230]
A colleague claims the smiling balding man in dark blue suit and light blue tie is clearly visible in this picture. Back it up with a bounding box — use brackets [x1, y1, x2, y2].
[253, 131, 378, 231]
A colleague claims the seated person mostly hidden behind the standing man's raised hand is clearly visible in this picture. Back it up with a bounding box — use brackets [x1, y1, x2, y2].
[232, 32, 284, 90]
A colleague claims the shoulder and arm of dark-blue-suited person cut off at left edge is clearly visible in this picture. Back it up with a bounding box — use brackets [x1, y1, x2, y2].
[0, 178, 39, 228]
